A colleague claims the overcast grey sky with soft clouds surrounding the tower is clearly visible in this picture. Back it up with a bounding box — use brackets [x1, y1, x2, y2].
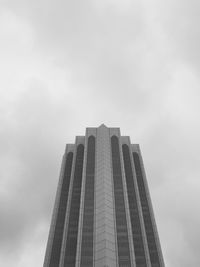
[0, 0, 200, 267]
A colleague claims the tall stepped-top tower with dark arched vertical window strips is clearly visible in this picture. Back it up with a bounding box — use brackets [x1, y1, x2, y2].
[44, 124, 164, 267]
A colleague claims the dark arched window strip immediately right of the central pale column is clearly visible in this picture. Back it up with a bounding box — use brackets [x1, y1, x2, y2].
[111, 136, 131, 267]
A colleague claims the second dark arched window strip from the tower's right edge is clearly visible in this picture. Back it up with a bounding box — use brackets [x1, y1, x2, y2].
[122, 145, 147, 267]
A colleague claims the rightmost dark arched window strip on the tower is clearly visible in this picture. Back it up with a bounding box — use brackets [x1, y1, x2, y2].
[133, 152, 161, 267]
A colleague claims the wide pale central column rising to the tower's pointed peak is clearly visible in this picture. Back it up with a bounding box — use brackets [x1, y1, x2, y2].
[94, 125, 117, 267]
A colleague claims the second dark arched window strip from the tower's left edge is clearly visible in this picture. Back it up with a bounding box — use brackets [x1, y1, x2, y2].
[64, 144, 84, 267]
